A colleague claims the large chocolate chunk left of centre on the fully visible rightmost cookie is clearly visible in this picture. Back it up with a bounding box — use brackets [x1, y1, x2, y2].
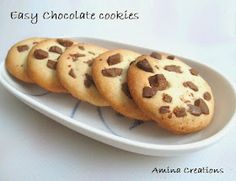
[148, 74, 168, 90]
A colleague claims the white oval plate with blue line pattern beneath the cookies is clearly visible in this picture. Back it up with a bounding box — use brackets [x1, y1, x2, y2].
[0, 38, 236, 156]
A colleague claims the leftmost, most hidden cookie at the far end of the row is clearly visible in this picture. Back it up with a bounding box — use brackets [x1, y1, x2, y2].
[6, 37, 44, 83]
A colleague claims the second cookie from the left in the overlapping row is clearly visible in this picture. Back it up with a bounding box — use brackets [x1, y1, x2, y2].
[27, 39, 75, 93]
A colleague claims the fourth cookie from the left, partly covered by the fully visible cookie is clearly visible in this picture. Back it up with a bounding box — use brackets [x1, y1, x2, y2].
[92, 49, 150, 120]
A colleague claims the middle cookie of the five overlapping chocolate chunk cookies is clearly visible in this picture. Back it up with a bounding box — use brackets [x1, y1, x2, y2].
[57, 44, 108, 106]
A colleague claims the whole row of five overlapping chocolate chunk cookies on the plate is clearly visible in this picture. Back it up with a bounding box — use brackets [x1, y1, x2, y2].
[6, 38, 214, 134]
